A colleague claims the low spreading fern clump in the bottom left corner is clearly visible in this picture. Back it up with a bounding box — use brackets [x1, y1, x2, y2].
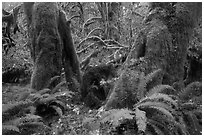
[2, 100, 50, 135]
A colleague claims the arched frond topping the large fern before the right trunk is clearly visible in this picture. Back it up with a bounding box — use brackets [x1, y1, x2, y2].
[146, 85, 176, 97]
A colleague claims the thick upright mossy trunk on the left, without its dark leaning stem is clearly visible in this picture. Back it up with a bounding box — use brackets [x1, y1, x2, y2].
[24, 3, 62, 90]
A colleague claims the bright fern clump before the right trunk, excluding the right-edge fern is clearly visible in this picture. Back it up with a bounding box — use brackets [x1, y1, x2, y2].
[83, 70, 188, 135]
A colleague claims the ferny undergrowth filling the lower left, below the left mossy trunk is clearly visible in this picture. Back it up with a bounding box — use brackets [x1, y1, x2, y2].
[2, 77, 74, 135]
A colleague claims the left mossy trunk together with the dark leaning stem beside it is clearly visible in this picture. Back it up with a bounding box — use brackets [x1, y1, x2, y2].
[24, 2, 81, 90]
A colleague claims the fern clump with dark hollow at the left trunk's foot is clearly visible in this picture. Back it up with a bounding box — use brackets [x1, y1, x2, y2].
[30, 76, 74, 119]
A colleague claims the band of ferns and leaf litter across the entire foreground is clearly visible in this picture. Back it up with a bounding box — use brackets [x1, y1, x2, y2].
[2, 70, 202, 135]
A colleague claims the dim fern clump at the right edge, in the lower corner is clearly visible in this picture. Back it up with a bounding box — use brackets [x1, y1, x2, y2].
[178, 82, 202, 135]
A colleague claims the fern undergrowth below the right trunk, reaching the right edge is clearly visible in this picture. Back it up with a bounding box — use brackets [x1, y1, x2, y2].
[81, 70, 202, 135]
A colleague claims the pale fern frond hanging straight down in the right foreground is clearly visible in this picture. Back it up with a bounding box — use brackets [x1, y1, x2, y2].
[135, 108, 147, 132]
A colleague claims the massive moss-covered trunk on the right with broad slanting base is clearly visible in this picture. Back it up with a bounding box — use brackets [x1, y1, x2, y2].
[105, 3, 202, 109]
